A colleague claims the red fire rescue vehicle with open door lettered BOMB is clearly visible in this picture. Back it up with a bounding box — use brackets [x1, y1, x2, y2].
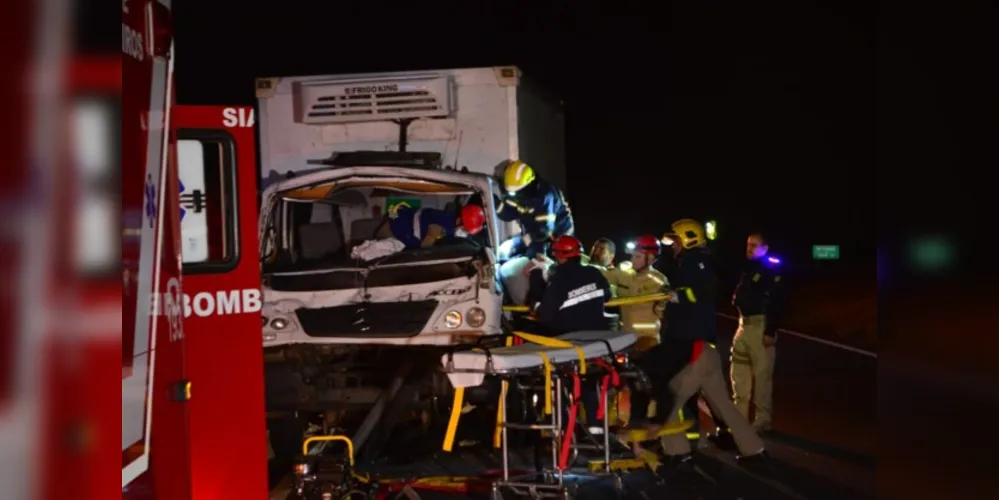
[121, 0, 267, 500]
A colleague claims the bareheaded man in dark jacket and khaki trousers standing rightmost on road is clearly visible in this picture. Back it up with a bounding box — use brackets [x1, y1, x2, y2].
[730, 233, 785, 432]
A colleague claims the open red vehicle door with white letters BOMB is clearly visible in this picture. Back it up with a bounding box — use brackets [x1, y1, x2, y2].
[173, 106, 268, 500]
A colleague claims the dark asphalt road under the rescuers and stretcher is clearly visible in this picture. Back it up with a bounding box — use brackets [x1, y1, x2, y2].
[272, 317, 878, 500]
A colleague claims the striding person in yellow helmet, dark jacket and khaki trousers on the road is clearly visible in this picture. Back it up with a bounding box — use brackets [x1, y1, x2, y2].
[643, 219, 767, 468]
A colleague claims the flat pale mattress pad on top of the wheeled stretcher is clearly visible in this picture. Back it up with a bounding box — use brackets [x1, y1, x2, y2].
[441, 331, 638, 387]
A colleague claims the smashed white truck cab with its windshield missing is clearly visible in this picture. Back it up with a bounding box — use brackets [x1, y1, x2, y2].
[260, 153, 503, 347]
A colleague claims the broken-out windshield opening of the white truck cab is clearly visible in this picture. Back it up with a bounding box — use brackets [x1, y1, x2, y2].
[262, 181, 490, 276]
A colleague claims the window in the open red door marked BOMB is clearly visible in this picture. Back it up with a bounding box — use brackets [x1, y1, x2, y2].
[177, 133, 237, 272]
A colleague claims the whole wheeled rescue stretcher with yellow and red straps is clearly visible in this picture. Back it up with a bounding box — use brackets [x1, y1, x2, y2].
[441, 318, 689, 499]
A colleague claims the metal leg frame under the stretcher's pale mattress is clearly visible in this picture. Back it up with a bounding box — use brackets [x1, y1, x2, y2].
[444, 336, 624, 500]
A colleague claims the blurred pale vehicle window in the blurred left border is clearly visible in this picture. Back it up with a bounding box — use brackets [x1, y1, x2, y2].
[70, 97, 120, 278]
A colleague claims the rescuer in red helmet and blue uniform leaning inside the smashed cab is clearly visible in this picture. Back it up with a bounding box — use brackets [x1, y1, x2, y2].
[390, 205, 486, 249]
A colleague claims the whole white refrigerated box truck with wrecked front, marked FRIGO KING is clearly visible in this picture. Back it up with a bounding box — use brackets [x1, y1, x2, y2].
[257, 67, 565, 418]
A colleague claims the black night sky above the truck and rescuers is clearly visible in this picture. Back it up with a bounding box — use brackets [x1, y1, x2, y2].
[174, 0, 875, 274]
